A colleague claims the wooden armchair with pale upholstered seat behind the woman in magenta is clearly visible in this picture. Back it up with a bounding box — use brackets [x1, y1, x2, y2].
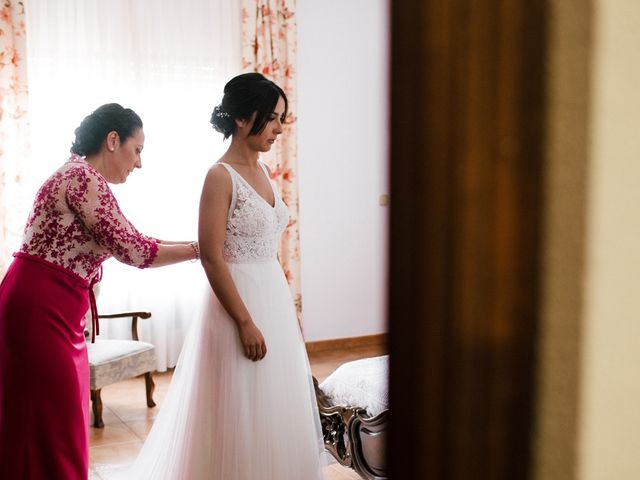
[85, 312, 156, 428]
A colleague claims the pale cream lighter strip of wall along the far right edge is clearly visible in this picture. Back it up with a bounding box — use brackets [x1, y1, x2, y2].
[579, 0, 640, 480]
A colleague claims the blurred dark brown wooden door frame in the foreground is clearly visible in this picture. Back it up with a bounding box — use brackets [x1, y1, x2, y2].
[388, 0, 545, 480]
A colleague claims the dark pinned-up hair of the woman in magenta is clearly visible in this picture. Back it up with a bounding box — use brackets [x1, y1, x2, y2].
[71, 103, 142, 156]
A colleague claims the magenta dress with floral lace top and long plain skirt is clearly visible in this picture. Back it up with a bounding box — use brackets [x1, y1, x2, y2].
[0, 155, 158, 480]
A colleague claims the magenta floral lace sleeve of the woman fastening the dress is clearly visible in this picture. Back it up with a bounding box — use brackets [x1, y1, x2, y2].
[66, 165, 158, 268]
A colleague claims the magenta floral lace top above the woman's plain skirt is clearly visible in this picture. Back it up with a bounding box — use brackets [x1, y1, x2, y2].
[20, 155, 158, 281]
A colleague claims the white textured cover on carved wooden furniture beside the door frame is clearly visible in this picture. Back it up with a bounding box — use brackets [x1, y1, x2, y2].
[320, 355, 389, 416]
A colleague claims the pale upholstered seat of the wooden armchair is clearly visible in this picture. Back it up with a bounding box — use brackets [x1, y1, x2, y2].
[87, 339, 155, 390]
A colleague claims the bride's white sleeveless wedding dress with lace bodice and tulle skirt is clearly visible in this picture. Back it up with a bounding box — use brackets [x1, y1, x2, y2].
[128, 164, 323, 480]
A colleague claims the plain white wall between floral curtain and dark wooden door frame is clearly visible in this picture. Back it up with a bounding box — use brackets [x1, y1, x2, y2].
[297, 0, 389, 341]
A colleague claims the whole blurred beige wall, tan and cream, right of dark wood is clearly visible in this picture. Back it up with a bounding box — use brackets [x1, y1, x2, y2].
[536, 0, 640, 480]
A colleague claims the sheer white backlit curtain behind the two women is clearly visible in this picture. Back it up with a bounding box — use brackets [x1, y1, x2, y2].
[27, 0, 241, 371]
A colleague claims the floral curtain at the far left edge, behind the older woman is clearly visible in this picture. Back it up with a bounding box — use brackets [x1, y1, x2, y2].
[0, 0, 28, 277]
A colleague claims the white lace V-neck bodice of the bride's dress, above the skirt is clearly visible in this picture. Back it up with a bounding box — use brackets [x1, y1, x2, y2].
[220, 162, 289, 263]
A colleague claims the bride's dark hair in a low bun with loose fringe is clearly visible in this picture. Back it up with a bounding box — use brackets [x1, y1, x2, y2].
[210, 73, 289, 139]
